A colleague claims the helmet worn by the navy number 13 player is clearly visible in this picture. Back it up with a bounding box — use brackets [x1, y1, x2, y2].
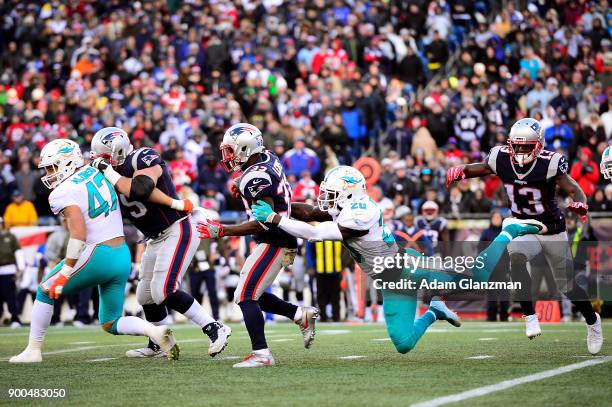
[508, 117, 544, 166]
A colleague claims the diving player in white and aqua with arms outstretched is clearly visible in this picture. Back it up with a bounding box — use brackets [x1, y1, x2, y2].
[252, 166, 544, 353]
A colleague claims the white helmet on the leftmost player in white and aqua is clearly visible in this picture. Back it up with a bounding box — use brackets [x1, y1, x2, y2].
[38, 139, 85, 189]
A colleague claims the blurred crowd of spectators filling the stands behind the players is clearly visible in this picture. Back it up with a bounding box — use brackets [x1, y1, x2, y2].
[0, 0, 612, 326]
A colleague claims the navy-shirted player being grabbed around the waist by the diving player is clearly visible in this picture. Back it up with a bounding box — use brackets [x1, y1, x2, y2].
[198, 123, 319, 368]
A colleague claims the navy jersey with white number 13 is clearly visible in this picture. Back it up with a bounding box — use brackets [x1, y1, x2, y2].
[485, 146, 568, 235]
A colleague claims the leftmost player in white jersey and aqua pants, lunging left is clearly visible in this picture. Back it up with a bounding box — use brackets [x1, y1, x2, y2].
[9, 139, 179, 363]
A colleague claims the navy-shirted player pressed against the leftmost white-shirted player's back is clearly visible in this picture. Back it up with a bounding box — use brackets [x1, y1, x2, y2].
[91, 127, 231, 357]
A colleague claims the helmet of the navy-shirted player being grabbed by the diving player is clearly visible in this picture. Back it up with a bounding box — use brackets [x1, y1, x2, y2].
[219, 123, 264, 172]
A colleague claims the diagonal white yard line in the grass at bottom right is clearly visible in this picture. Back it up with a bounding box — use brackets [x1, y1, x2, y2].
[411, 356, 612, 407]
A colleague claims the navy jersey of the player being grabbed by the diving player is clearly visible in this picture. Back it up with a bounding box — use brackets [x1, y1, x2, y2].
[238, 151, 297, 249]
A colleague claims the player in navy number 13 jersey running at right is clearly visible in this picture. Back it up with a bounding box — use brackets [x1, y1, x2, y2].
[446, 118, 603, 354]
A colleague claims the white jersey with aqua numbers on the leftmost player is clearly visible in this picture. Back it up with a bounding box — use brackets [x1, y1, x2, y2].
[49, 165, 123, 245]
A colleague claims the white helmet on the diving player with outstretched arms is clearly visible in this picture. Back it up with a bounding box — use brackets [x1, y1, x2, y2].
[317, 165, 366, 215]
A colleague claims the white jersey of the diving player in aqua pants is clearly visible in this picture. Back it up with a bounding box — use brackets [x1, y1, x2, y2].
[334, 197, 399, 275]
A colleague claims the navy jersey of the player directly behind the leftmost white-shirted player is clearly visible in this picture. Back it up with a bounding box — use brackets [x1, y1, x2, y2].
[115, 147, 187, 238]
